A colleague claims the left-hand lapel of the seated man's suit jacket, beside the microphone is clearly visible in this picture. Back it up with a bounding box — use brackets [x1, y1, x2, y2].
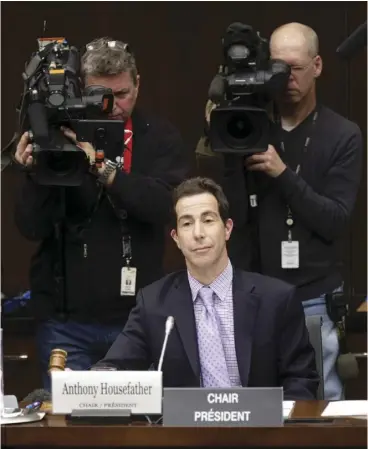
[170, 275, 200, 382]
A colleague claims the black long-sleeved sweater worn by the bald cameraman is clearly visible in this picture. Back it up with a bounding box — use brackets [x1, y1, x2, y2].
[224, 106, 362, 300]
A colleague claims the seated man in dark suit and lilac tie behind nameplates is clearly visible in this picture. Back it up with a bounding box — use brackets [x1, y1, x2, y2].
[95, 178, 319, 399]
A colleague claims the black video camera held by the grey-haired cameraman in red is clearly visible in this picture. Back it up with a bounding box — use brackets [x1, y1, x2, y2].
[19, 38, 124, 186]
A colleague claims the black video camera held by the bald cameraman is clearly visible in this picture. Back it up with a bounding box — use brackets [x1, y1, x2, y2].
[209, 23, 290, 155]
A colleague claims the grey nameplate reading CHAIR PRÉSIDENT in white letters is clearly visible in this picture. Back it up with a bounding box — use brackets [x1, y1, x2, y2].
[163, 388, 283, 427]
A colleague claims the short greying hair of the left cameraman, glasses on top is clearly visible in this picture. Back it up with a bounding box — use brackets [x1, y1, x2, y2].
[82, 37, 138, 85]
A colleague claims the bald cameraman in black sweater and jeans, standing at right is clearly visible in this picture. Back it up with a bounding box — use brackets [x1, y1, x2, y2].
[220, 23, 362, 400]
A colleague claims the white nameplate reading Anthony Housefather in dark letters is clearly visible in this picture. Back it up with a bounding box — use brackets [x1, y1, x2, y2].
[51, 371, 162, 415]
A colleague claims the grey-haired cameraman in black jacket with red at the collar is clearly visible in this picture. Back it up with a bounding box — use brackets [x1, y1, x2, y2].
[15, 38, 186, 389]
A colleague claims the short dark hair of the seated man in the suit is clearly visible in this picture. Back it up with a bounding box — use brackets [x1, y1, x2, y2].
[173, 177, 229, 225]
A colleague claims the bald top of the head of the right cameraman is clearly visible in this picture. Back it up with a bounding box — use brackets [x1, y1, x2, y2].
[270, 22, 319, 58]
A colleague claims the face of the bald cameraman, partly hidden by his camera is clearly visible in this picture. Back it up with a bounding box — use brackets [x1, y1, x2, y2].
[271, 41, 322, 103]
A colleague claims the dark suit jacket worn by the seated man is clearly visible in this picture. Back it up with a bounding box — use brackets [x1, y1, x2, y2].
[98, 270, 319, 400]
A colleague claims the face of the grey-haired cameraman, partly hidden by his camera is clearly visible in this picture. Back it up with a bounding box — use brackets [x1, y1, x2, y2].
[86, 72, 139, 120]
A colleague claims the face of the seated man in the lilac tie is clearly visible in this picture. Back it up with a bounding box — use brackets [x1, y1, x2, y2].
[171, 193, 233, 269]
